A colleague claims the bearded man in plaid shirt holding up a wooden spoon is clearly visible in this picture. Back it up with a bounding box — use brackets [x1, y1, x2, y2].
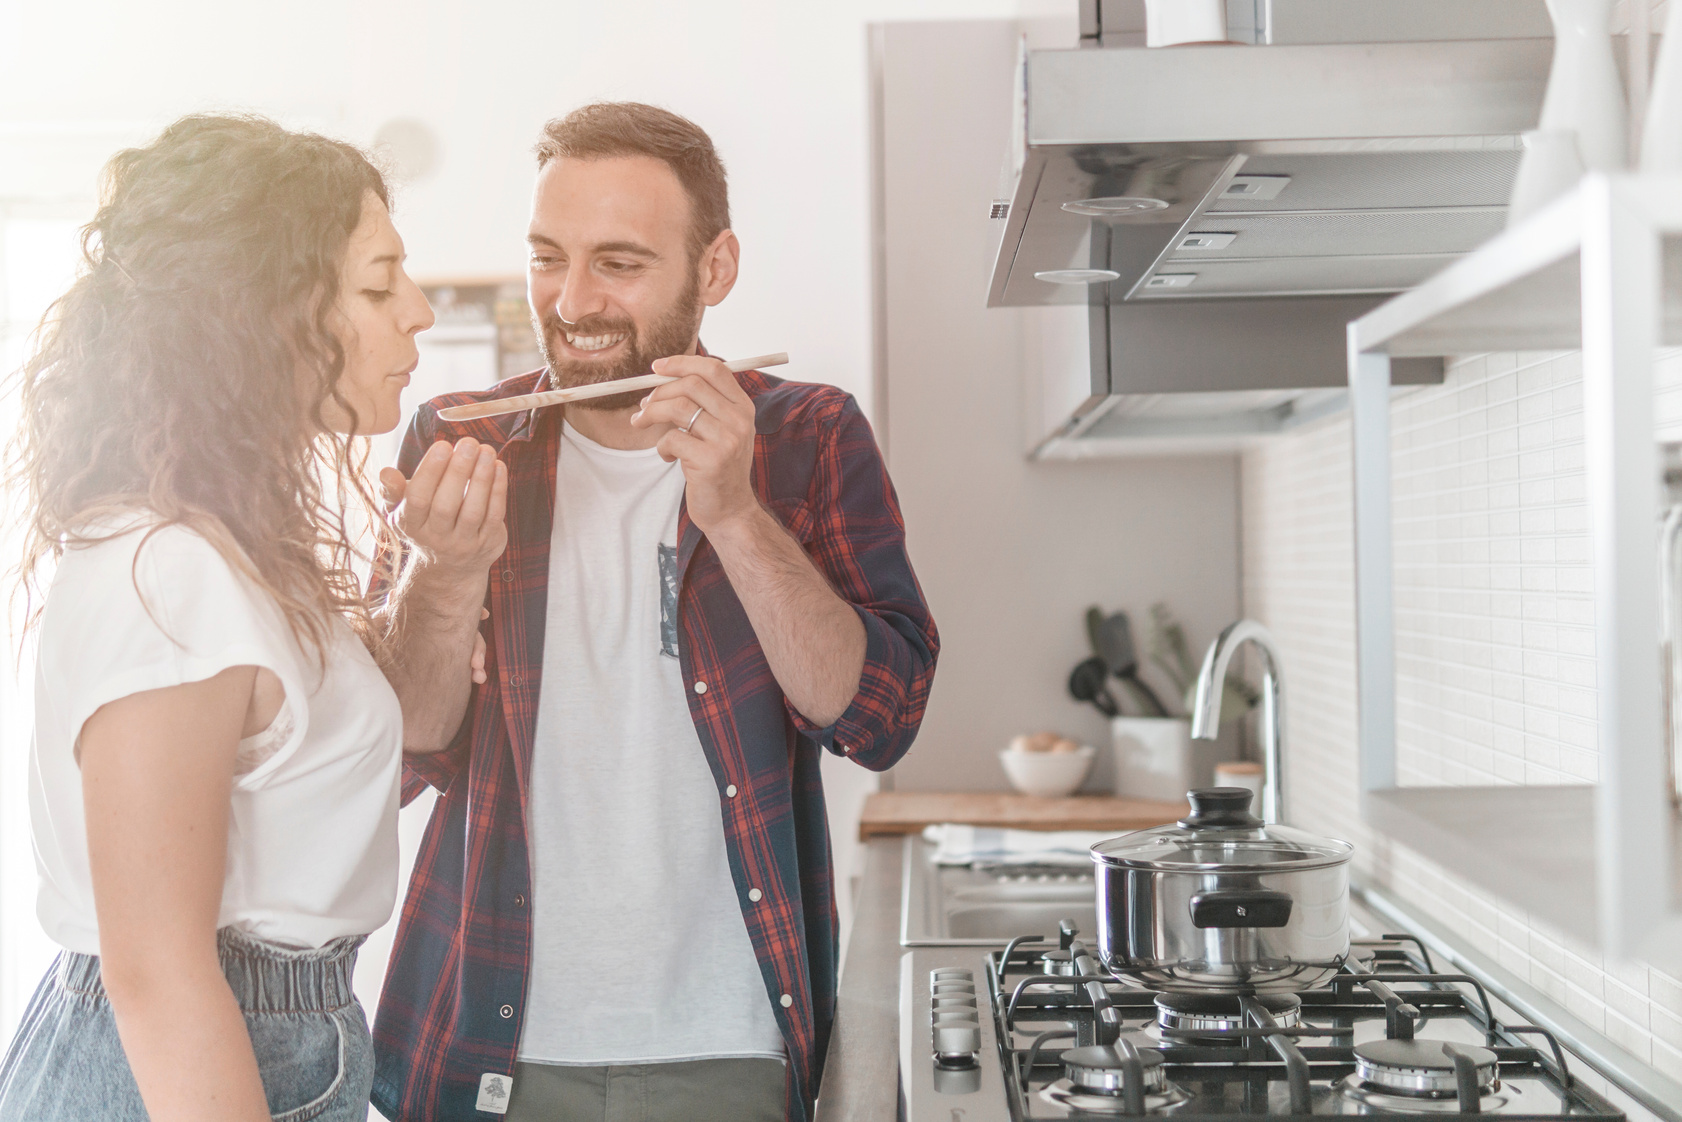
[373, 104, 937, 1122]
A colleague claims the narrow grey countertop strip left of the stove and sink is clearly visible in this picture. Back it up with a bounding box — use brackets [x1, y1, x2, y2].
[816, 838, 905, 1122]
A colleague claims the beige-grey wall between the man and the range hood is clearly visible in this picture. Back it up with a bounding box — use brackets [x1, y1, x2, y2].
[881, 19, 1238, 791]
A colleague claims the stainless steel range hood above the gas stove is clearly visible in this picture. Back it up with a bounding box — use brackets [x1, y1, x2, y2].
[987, 0, 1552, 457]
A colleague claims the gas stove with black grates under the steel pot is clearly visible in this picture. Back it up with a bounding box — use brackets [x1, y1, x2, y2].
[900, 922, 1625, 1122]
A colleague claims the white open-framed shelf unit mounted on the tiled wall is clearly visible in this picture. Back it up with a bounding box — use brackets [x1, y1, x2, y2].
[1349, 175, 1682, 962]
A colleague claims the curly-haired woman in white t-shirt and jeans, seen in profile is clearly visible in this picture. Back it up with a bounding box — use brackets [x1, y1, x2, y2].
[0, 116, 501, 1122]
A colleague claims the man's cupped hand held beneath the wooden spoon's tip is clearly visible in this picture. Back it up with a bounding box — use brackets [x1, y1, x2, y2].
[380, 436, 508, 580]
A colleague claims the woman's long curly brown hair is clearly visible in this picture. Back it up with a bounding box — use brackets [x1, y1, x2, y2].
[8, 116, 395, 659]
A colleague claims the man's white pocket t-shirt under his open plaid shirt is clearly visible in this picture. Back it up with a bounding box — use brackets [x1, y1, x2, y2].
[520, 424, 784, 1065]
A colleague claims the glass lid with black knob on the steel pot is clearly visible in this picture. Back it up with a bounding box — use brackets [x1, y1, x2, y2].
[1092, 787, 1354, 873]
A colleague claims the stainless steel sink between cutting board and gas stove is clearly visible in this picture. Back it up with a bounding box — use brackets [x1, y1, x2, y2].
[900, 836, 1097, 947]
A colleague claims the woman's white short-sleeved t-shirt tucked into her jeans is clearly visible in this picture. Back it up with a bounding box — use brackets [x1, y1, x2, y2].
[29, 523, 402, 954]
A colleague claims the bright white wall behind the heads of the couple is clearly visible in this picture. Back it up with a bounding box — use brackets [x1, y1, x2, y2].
[0, 0, 1073, 408]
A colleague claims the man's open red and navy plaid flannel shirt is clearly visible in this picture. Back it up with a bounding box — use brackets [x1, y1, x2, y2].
[373, 370, 939, 1122]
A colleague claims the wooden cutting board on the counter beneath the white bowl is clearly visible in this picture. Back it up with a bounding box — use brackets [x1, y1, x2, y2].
[858, 791, 1191, 841]
